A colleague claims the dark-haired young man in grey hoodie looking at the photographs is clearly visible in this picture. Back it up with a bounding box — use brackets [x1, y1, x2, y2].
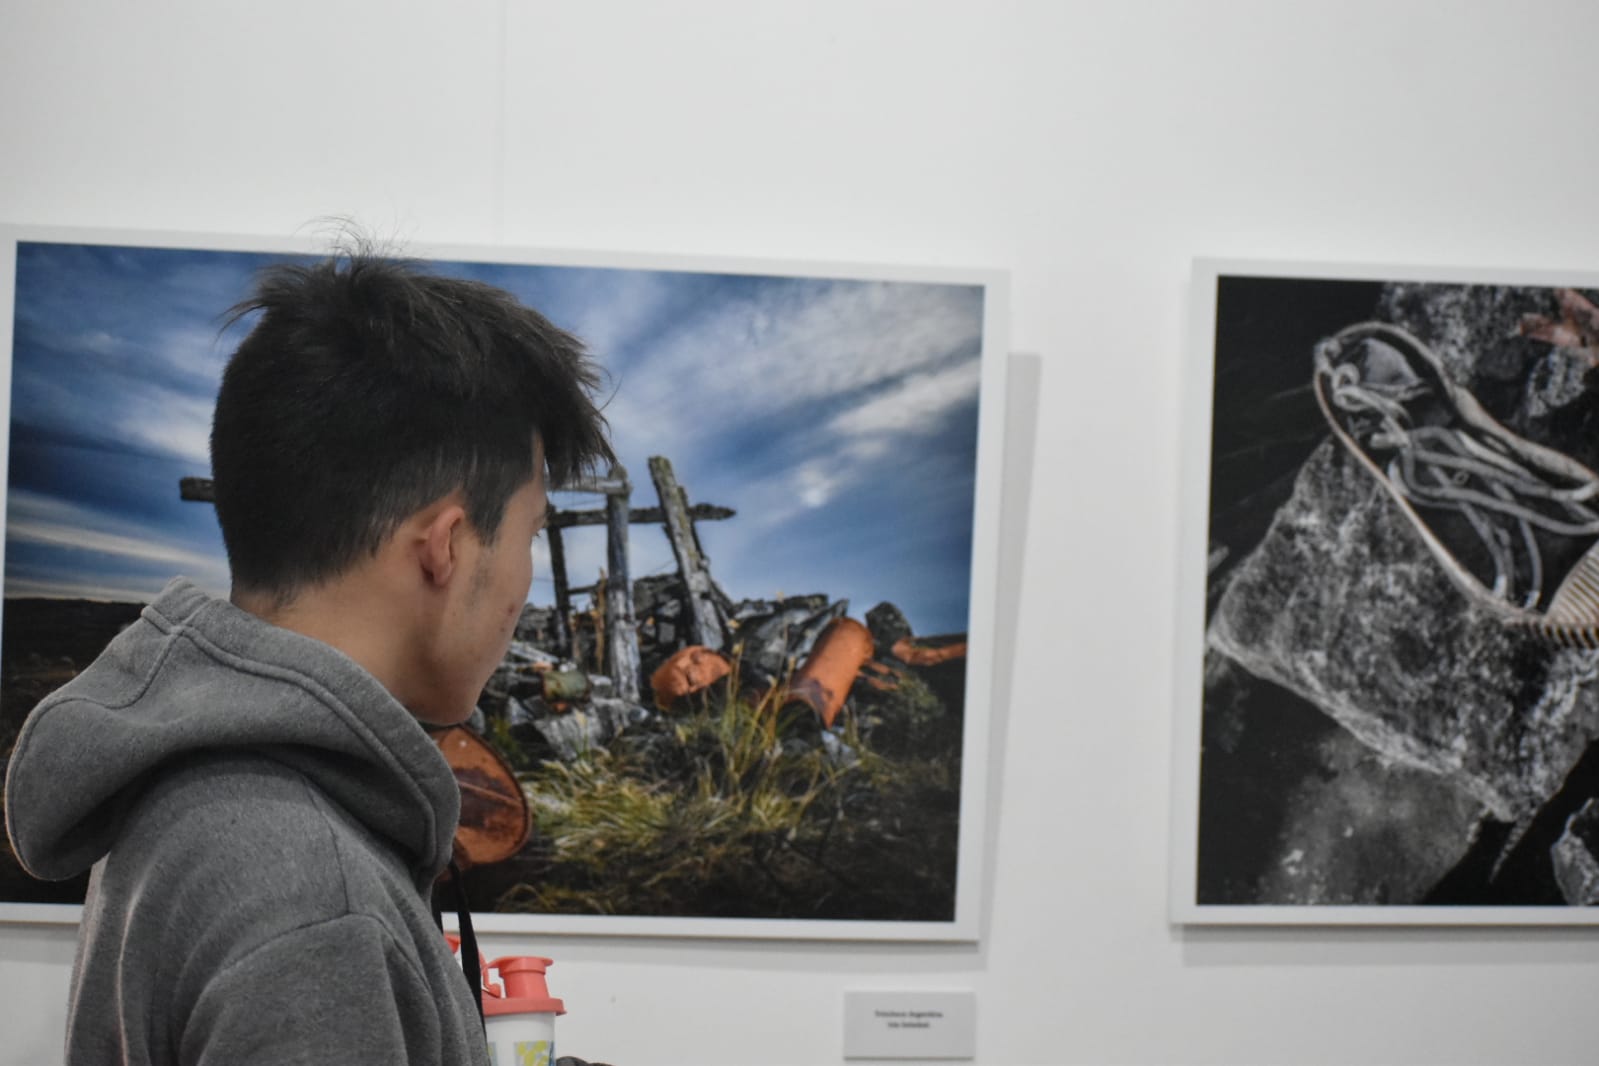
[6, 246, 611, 1066]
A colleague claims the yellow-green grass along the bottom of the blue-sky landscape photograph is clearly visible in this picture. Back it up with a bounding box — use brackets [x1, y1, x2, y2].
[497, 658, 958, 917]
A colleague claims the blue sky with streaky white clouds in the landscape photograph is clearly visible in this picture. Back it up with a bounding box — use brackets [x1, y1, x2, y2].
[5, 243, 983, 634]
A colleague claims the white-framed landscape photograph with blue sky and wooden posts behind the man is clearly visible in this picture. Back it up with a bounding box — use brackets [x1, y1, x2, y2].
[0, 229, 1007, 941]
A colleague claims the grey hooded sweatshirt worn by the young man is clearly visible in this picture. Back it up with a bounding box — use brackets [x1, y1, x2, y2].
[5, 580, 488, 1066]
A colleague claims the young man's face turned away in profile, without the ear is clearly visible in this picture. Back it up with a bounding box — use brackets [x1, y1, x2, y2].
[413, 455, 548, 726]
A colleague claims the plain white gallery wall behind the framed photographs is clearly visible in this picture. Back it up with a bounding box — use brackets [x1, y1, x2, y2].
[0, 0, 1599, 1066]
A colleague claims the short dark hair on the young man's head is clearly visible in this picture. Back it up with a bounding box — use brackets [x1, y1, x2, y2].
[211, 249, 614, 603]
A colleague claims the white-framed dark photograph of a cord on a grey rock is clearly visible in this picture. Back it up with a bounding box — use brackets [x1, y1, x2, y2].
[1172, 262, 1599, 924]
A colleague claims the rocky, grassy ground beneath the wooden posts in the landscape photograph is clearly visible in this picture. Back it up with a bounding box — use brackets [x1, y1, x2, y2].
[467, 591, 966, 921]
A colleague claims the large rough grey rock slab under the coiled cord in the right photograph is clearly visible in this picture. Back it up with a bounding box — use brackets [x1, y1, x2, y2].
[1207, 441, 1599, 820]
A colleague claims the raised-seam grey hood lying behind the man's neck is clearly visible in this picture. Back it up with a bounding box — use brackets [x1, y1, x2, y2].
[5, 579, 461, 887]
